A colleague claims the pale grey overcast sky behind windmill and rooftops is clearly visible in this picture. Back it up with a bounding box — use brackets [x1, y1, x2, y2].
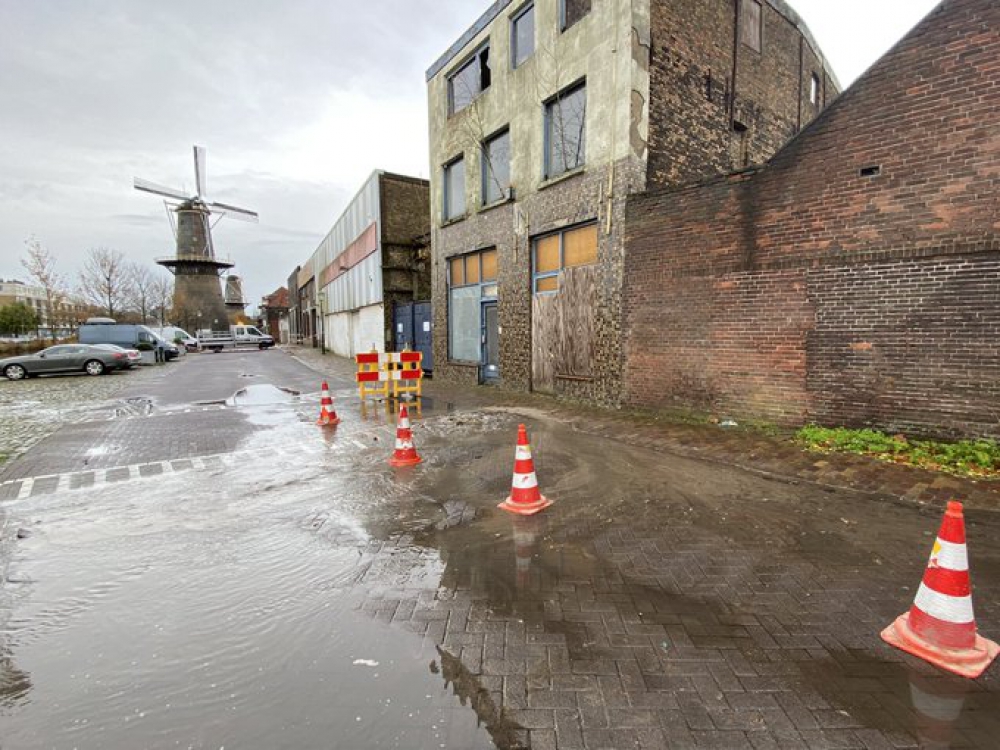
[0, 0, 937, 312]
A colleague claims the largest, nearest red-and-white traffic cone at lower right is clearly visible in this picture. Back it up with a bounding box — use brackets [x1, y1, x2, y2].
[882, 501, 1000, 678]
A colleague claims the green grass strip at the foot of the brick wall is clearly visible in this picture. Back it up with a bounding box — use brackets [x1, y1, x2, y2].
[795, 425, 1000, 479]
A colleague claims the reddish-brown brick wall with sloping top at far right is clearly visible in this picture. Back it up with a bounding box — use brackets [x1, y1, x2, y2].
[624, 0, 1000, 436]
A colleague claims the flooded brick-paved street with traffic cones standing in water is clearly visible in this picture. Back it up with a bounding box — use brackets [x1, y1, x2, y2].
[0, 351, 1000, 750]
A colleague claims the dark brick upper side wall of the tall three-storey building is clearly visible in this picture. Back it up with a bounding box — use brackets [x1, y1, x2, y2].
[649, 0, 837, 187]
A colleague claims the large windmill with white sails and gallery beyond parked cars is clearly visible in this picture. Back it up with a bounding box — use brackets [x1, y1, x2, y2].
[135, 146, 257, 329]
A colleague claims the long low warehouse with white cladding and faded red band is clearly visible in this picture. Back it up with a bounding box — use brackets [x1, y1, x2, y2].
[288, 170, 430, 357]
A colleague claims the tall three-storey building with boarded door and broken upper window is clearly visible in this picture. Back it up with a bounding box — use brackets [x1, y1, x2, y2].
[427, 0, 839, 404]
